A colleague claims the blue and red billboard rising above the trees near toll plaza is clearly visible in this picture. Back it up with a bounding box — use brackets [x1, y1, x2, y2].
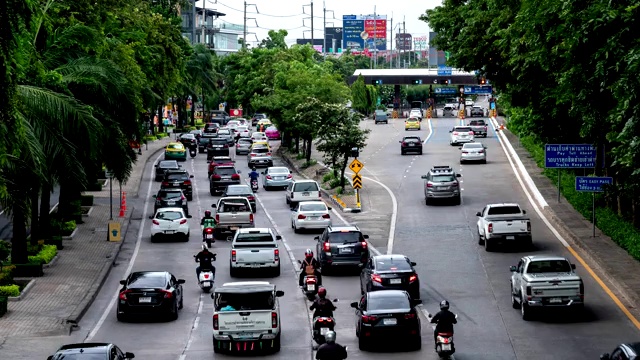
[342, 15, 387, 51]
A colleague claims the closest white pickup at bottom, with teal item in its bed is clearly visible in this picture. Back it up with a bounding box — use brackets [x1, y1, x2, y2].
[211, 281, 284, 355]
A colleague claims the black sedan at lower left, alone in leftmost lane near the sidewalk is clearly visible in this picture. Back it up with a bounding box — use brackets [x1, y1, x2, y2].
[116, 271, 185, 321]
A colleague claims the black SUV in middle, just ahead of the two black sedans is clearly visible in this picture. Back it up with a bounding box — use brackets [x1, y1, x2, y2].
[314, 226, 369, 270]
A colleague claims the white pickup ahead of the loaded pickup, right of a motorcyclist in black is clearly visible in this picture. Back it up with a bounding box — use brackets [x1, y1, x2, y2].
[229, 228, 282, 277]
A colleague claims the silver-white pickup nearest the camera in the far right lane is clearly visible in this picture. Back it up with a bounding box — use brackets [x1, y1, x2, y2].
[510, 255, 584, 321]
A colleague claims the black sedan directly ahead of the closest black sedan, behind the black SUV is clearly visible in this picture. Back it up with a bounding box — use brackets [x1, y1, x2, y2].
[360, 255, 420, 299]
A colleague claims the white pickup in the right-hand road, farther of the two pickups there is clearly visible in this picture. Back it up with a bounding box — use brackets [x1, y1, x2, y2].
[476, 203, 532, 251]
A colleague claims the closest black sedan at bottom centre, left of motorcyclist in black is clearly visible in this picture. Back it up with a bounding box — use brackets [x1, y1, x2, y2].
[351, 290, 422, 350]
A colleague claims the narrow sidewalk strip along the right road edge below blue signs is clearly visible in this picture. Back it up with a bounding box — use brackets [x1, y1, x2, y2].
[496, 117, 640, 316]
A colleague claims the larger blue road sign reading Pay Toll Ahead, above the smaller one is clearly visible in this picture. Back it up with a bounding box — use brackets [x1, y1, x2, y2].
[544, 144, 596, 169]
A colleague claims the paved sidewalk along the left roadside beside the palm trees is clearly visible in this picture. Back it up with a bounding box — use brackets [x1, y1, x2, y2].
[0, 138, 169, 343]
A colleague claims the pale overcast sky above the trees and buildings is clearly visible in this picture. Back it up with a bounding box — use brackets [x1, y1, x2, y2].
[197, 0, 442, 44]
